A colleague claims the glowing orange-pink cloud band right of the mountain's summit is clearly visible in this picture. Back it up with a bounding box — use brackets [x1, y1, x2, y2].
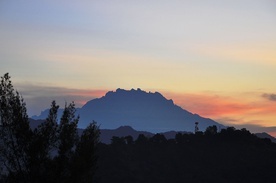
[165, 92, 276, 122]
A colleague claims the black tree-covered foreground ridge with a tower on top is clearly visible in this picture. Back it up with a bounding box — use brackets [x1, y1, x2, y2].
[95, 126, 276, 183]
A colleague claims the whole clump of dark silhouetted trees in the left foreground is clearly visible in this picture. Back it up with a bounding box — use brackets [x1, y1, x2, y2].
[0, 74, 99, 183]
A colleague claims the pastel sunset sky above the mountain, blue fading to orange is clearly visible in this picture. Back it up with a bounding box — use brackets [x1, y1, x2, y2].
[0, 0, 276, 137]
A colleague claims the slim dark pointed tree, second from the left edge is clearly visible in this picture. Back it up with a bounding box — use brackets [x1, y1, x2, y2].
[29, 101, 59, 182]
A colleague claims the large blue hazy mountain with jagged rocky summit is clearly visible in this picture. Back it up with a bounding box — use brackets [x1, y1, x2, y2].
[33, 89, 223, 133]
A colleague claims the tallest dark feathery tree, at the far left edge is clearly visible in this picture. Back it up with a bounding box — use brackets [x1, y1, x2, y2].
[0, 73, 32, 182]
